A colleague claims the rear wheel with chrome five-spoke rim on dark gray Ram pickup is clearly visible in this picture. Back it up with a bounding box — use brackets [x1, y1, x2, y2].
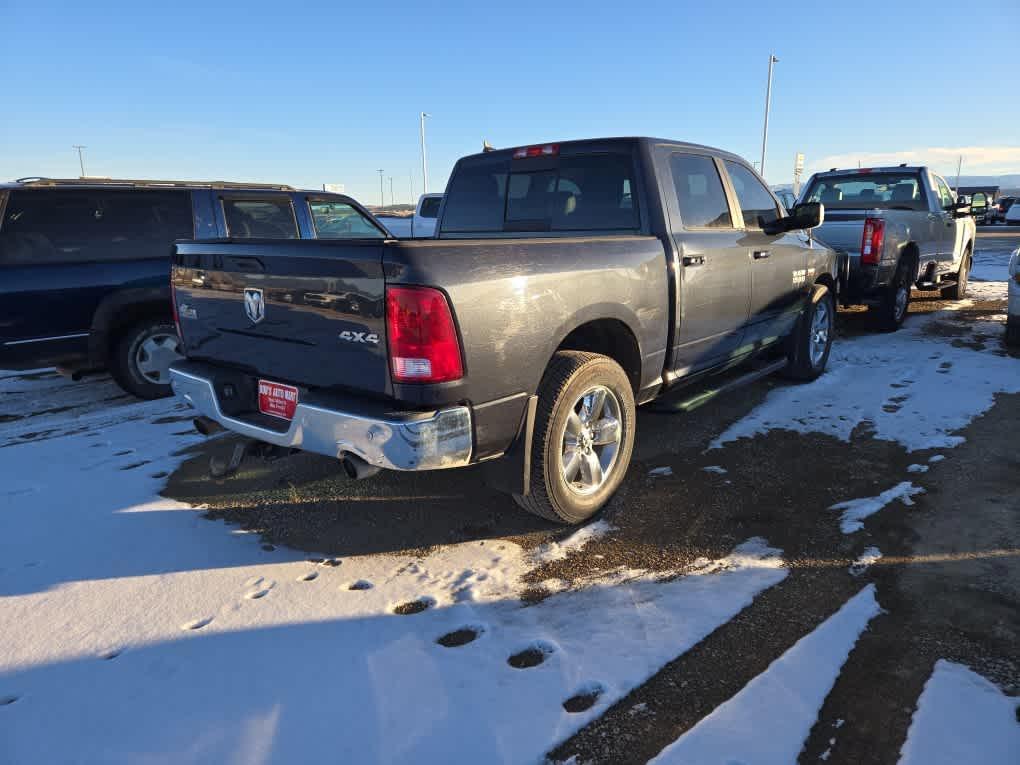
[514, 351, 634, 523]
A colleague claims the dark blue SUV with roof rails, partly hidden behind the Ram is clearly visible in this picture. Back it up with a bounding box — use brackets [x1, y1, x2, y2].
[0, 179, 389, 399]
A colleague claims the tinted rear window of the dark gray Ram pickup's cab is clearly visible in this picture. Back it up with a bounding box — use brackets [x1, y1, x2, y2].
[442, 153, 641, 234]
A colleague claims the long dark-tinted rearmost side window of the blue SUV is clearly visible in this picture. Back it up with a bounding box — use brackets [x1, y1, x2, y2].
[0, 189, 194, 263]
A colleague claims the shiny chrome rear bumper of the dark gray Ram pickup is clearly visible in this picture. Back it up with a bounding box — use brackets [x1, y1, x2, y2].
[170, 362, 472, 470]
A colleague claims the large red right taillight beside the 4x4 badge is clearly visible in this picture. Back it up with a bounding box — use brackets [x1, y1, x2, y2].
[386, 287, 464, 383]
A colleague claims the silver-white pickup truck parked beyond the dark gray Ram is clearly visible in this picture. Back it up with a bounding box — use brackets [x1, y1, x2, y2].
[801, 165, 976, 330]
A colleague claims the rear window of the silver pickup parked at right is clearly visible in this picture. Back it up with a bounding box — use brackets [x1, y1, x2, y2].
[804, 172, 928, 210]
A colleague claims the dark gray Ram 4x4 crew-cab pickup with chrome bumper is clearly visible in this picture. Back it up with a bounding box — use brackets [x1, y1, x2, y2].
[171, 138, 836, 523]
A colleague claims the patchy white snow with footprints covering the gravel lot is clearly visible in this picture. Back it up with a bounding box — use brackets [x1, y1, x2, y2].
[0, 273, 1020, 765]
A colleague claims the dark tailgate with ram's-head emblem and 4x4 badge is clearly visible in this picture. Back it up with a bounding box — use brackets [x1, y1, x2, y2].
[171, 240, 390, 395]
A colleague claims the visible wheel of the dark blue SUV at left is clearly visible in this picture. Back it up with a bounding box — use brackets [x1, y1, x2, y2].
[110, 318, 182, 399]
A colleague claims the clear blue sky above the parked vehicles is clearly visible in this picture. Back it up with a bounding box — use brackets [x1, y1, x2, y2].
[0, 0, 1020, 204]
